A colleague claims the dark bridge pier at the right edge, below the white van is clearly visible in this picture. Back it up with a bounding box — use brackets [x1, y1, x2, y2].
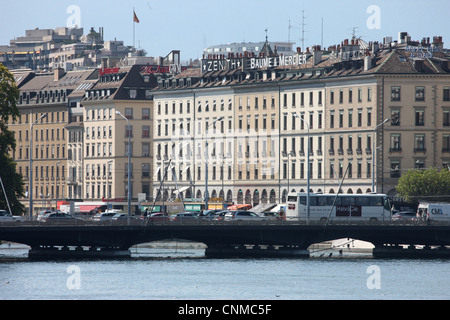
[372, 245, 450, 258]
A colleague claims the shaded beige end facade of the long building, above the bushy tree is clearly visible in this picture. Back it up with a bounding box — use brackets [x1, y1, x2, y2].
[379, 51, 450, 193]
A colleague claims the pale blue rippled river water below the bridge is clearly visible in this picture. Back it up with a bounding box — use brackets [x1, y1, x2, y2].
[0, 244, 450, 300]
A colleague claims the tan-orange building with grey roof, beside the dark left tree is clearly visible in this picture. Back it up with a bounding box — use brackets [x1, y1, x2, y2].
[10, 69, 97, 211]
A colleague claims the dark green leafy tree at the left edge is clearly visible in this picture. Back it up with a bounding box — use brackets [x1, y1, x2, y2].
[0, 63, 25, 214]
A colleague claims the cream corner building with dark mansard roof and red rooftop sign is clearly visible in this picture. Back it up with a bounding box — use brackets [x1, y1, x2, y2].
[78, 65, 156, 203]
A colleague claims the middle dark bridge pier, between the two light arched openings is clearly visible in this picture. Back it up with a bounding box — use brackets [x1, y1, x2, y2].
[205, 245, 310, 258]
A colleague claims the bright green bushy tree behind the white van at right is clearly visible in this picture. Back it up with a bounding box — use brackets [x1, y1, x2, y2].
[397, 169, 450, 202]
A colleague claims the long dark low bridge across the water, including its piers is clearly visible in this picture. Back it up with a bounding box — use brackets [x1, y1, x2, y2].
[0, 220, 450, 259]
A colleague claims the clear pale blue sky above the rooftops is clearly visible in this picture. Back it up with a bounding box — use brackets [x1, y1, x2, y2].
[0, 0, 450, 61]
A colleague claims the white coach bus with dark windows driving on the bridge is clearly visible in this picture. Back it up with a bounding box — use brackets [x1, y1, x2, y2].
[286, 193, 392, 223]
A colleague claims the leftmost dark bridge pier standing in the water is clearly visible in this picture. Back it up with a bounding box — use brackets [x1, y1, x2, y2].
[28, 246, 131, 260]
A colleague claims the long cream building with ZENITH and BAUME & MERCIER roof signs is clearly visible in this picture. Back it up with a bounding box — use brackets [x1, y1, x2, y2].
[155, 33, 450, 204]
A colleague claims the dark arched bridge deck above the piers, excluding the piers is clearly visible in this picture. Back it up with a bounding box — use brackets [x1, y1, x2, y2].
[0, 224, 450, 250]
